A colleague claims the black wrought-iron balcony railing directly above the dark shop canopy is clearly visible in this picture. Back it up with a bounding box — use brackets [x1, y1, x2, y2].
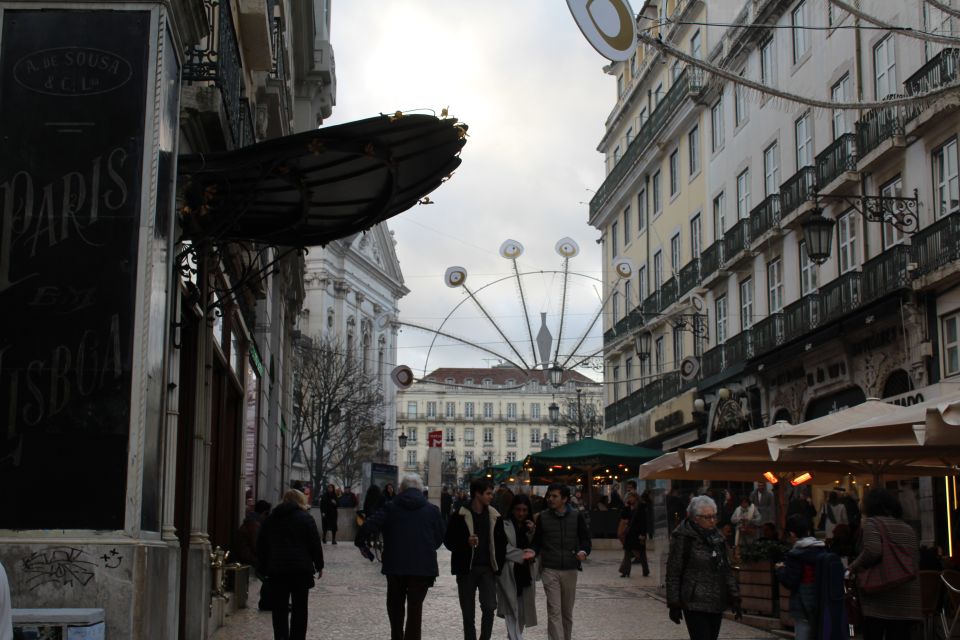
[182, 0, 253, 148]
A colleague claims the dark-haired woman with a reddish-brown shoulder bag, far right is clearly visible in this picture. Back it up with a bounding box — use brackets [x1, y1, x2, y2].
[849, 487, 923, 640]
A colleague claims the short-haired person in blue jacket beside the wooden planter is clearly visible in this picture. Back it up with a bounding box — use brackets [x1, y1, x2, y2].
[776, 513, 827, 640]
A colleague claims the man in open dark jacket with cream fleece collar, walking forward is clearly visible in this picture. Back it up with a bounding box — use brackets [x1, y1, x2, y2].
[443, 480, 507, 640]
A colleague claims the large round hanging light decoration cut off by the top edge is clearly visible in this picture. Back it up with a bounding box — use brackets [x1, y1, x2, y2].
[567, 0, 637, 62]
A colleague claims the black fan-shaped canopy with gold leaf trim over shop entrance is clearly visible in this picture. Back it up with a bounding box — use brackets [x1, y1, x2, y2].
[179, 114, 466, 247]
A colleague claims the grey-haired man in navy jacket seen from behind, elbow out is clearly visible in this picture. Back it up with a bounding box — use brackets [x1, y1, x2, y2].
[360, 474, 443, 640]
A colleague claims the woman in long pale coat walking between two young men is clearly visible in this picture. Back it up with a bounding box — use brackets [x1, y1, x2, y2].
[497, 493, 537, 640]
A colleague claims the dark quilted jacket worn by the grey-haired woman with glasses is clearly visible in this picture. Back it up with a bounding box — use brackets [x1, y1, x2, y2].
[667, 520, 740, 613]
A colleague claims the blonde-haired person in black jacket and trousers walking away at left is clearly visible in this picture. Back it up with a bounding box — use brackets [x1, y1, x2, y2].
[257, 489, 323, 640]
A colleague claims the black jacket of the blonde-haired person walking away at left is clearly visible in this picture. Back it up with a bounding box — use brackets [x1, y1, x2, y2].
[257, 502, 323, 577]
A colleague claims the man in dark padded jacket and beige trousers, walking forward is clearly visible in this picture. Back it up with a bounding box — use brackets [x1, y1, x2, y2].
[530, 484, 590, 640]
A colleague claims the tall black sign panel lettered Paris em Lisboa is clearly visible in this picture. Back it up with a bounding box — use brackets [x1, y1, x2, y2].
[0, 10, 150, 529]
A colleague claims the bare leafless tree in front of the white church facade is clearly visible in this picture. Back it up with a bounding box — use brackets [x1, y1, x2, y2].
[293, 336, 383, 492]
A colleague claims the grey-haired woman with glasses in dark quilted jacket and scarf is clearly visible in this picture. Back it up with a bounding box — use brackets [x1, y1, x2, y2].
[666, 496, 742, 640]
